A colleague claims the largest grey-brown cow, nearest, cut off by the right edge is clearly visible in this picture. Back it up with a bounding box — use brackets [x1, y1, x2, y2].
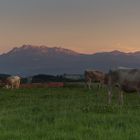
[106, 67, 140, 105]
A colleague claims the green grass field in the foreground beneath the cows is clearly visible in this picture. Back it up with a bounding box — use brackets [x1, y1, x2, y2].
[0, 87, 140, 140]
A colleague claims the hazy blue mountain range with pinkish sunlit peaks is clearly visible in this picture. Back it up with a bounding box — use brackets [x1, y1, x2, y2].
[0, 45, 140, 76]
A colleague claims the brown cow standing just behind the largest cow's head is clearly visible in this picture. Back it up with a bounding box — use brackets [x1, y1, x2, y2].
[84, 70, 105, 89]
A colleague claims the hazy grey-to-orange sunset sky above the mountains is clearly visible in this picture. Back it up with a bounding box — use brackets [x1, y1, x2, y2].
[0, 0, 140, 53]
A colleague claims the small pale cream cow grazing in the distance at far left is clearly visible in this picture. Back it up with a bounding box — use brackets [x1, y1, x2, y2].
[4, 76, 21, 89]
